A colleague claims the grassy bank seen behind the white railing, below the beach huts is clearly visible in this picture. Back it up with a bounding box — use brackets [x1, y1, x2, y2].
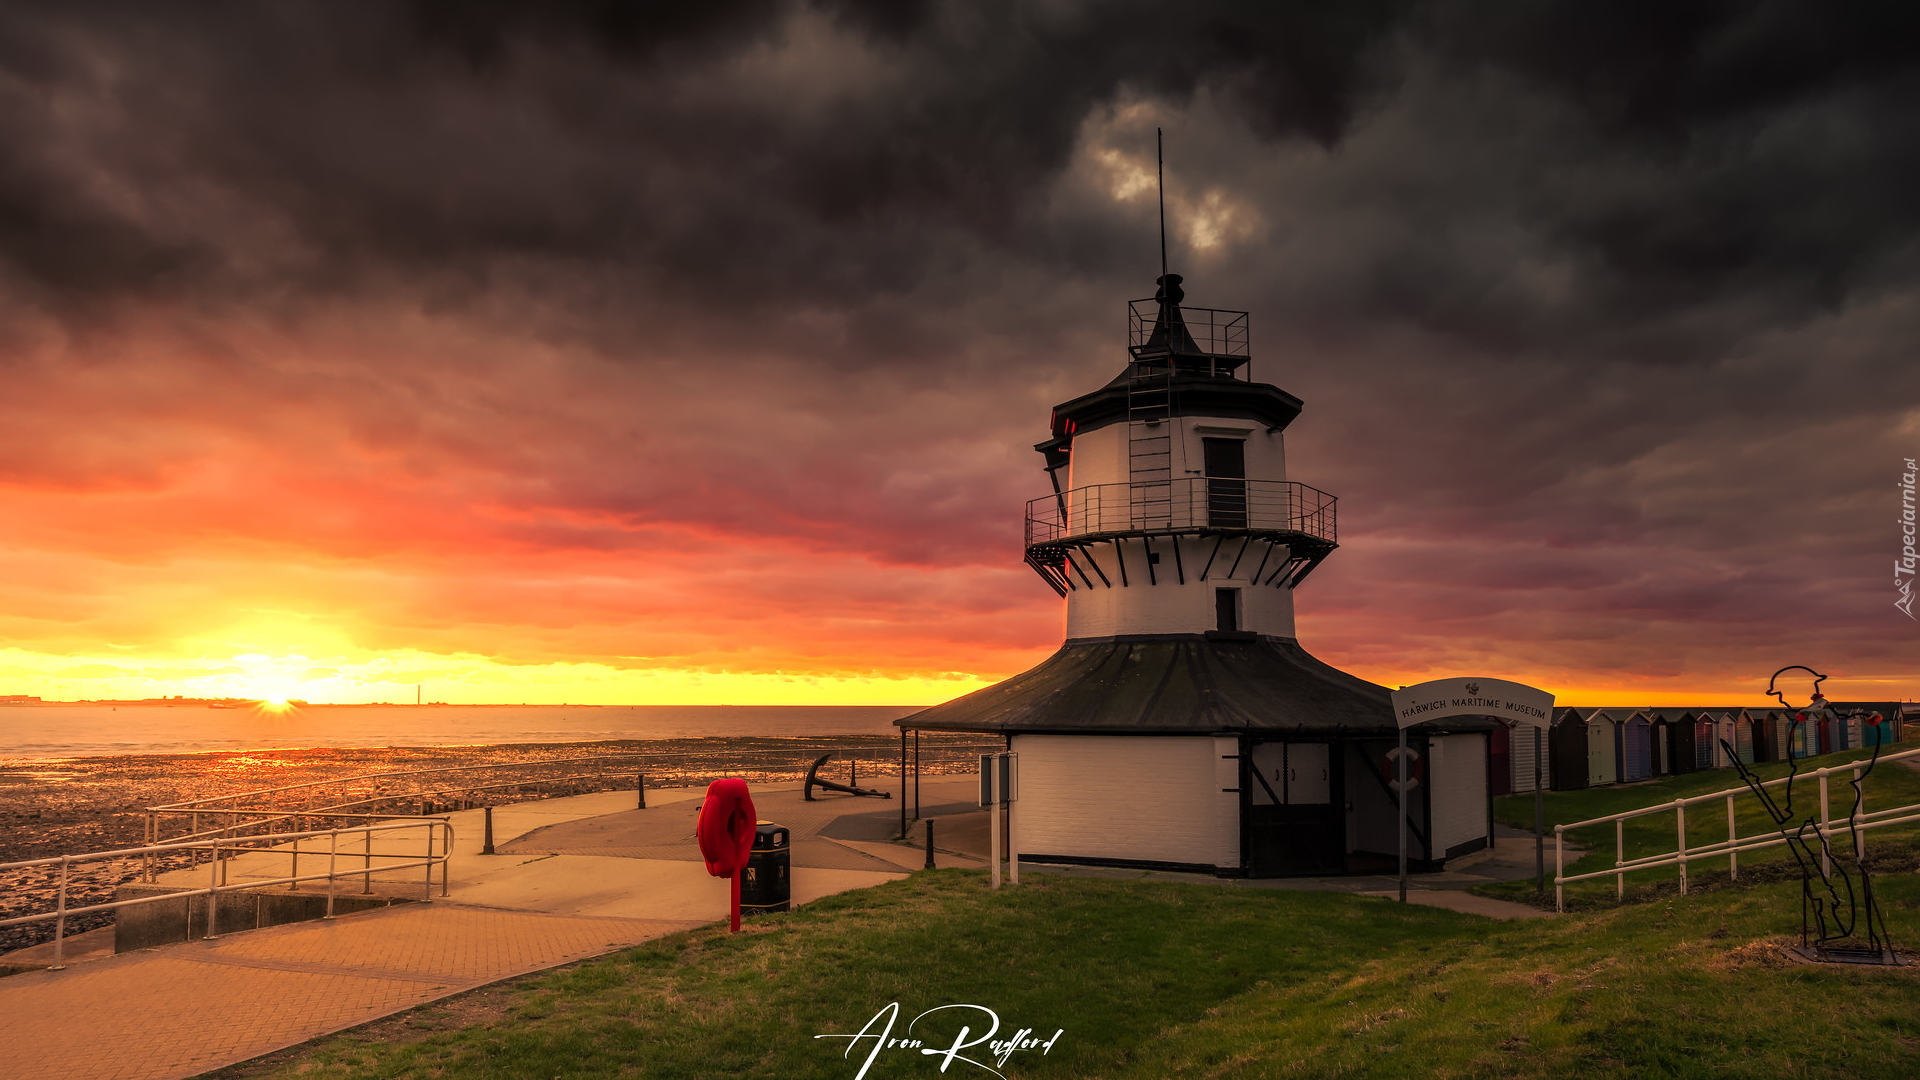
[1475, 744, 1920, 911]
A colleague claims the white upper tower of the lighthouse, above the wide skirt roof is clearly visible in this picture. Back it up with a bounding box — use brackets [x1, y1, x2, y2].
[1027, 275, 1334, 642]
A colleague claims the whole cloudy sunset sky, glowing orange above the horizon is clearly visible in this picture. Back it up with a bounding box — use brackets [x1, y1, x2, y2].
[0, 0, 1920, 703]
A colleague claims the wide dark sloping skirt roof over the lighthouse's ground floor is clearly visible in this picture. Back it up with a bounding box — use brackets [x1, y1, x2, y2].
[895, 634, 1494, 738]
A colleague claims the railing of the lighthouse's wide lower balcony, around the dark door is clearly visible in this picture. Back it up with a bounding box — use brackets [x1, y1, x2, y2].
[1027, 477, 1338, 548]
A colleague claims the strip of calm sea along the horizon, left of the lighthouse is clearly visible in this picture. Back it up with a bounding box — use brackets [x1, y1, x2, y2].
[0, 703, 920, 759]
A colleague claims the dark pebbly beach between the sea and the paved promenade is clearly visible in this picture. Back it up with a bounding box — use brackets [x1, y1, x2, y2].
[0, 736, 977, 953]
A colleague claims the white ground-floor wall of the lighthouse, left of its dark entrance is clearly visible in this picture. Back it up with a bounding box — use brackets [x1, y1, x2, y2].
[1014, 734, 1240, 867]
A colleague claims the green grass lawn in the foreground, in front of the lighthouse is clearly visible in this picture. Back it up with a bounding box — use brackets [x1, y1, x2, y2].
[224, 871, 1920, 1080]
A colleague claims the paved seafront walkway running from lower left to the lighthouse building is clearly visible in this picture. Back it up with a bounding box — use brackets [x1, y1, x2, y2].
[0, 778, 1551, 1080]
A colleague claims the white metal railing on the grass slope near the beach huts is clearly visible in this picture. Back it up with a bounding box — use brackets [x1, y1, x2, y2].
[1553, 737, 1920, 911]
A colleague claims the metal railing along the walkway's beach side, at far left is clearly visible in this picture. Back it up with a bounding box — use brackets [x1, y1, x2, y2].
[0, 819, 453, 970]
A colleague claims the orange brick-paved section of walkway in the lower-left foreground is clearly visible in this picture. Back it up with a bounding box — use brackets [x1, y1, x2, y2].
[0, 901, 699, 1080]
